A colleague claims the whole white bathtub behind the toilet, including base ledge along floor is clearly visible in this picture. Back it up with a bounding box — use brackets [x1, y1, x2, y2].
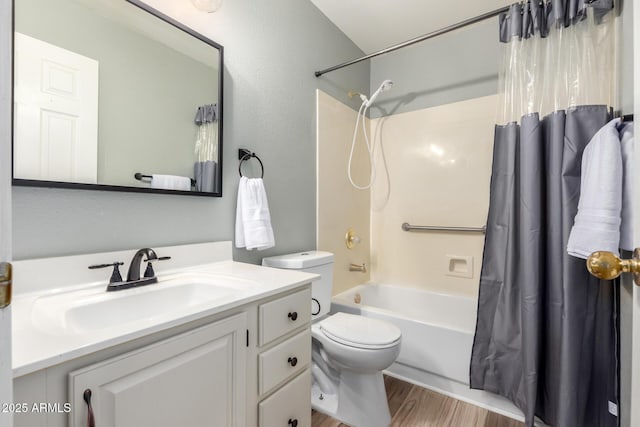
[331, 283, 524, 421]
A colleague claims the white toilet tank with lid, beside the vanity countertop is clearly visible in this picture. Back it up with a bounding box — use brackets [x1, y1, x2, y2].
[262, 251, 333, 318]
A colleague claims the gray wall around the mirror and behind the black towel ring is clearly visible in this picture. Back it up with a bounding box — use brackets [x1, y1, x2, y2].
[13, 0, 369, 263]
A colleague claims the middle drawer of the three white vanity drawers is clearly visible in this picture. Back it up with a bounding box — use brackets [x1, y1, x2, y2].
[258, 329, 311, 395]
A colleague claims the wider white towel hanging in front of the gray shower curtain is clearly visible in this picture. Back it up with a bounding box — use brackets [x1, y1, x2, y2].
[567, 119, 622, 259]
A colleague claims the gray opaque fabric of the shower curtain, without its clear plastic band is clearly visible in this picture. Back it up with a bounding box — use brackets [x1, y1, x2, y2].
[470, 1, 618, 427]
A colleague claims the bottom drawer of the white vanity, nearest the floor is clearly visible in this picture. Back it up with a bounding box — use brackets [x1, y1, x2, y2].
[258, 369, 311, 427]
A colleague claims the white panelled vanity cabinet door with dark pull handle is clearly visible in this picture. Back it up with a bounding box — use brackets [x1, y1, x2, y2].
[69, 313, 247, 427]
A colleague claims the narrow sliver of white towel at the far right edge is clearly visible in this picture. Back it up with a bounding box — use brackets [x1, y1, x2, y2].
[620, 123, 634, 251]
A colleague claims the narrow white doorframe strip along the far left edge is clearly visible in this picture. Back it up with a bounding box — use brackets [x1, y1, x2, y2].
[0, 1, 13, 427]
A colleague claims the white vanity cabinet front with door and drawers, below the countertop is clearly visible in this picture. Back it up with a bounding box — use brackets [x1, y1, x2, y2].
[14, 284, 311, 427]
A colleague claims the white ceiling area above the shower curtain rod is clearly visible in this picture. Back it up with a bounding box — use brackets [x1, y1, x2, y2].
[311, 0, 515, 53]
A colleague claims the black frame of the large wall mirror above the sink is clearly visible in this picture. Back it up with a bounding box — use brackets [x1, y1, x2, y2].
[11, 0, 224, 197]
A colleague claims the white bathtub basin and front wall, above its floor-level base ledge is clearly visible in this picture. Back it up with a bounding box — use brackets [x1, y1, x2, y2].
[331, 284, 477, 385]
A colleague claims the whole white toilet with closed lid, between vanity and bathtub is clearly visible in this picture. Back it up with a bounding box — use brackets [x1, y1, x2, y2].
[262, 251, 402, 427]
